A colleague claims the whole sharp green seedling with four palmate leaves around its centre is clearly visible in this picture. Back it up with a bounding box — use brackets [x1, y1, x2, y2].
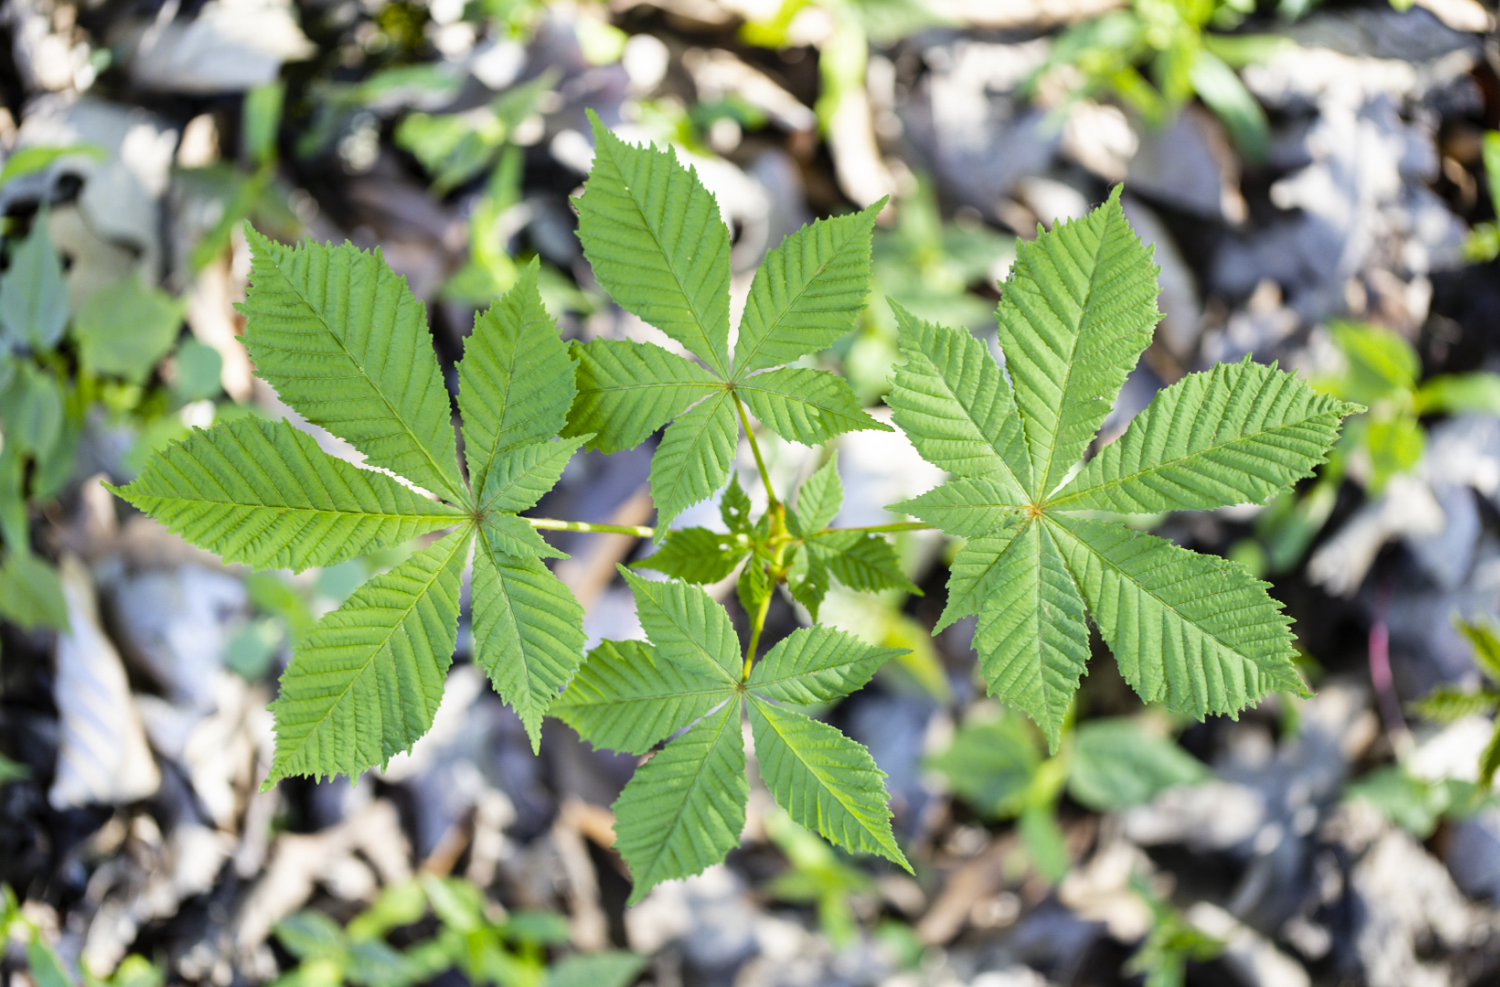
[119, 119, 1349, 902]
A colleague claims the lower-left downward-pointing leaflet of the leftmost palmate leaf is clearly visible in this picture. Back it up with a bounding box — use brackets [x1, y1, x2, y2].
[264, 531, 468, 789]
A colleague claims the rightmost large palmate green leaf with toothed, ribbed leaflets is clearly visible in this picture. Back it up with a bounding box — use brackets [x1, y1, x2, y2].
[888, 195, 1356, 747]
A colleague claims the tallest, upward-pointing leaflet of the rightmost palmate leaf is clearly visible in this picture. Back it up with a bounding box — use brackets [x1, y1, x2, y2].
[996, 186, 1160, 498]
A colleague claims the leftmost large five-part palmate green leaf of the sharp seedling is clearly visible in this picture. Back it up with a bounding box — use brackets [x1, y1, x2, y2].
[119, 237, 584, 782]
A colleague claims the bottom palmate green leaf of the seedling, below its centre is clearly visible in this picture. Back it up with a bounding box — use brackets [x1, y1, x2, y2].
[554, 569, 906, 903]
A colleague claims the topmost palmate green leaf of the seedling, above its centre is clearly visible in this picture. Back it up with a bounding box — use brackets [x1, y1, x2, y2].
[564, 116, 888, 533]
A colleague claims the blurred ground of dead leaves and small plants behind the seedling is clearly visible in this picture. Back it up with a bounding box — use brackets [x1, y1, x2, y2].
[0, 0, 1500, 987]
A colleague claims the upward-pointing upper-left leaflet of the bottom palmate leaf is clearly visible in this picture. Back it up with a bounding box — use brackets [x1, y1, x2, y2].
[620, 566, 741, 683]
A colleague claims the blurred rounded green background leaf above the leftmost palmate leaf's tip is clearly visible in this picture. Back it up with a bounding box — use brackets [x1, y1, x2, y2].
[74, 272, 183, 384]
